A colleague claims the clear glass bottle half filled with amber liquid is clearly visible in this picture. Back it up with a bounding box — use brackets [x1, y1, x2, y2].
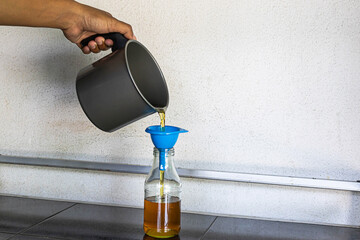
[144, 147, 181, 238]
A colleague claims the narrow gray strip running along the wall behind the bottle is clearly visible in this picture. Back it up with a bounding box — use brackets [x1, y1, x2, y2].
[0, 155, 360, 192]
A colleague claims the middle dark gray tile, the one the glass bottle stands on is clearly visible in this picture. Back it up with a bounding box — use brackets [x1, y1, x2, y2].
[25, 204, 215, 240]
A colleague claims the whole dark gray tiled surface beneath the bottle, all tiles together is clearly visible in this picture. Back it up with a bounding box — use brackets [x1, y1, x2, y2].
[0, 196, 360, 240]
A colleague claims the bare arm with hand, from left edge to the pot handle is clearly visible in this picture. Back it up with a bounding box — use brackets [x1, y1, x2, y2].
[0, 0, 136, 53]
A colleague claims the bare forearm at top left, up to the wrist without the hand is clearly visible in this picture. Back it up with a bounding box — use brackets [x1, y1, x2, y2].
[0, 0, 81, 29]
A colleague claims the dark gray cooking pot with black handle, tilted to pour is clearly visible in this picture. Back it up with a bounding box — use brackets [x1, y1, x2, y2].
[76, 33, 169, 132]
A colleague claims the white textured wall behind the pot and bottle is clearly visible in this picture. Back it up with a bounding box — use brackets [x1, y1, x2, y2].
[0, 0, 360, 225]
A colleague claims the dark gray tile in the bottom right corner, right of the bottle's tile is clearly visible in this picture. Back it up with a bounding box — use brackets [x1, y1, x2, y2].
[204, 217, 360, 240]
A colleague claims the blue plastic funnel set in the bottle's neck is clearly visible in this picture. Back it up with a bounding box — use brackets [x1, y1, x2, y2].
[145, 125, 188, 171]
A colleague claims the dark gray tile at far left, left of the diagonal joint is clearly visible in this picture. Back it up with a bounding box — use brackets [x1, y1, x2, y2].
[0, 196, 73, 232]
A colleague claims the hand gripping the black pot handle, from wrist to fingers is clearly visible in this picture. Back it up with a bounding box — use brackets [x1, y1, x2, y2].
[62, 3, 136, 54]
